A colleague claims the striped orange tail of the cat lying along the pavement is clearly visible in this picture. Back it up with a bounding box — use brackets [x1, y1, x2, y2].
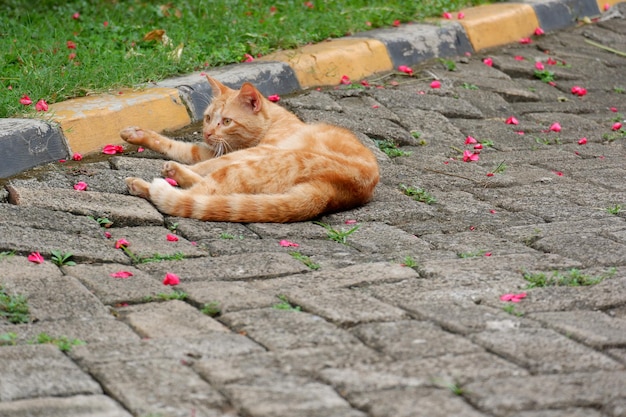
[150, 178, 364, 223]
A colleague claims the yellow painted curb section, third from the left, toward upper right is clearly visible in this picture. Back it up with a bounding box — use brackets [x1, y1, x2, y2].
[459, 3, 539, 51]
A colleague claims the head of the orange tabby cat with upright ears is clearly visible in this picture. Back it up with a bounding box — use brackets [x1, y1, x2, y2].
[202, 76, 271, 156]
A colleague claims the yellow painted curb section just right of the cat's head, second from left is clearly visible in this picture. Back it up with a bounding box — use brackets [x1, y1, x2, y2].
[261, 38, 393, 88]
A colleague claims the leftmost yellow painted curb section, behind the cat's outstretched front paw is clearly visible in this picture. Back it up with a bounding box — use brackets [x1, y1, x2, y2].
[50, 88, 191, 154]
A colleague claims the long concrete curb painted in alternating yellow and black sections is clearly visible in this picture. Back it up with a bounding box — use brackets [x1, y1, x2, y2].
[0, 0, 625, 178]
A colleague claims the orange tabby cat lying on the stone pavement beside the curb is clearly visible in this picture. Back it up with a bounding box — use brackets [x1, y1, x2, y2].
[120, 77, 379, 223]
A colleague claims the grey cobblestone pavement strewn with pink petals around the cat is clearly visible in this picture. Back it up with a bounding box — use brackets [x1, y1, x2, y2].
[0, 5, 626, 417]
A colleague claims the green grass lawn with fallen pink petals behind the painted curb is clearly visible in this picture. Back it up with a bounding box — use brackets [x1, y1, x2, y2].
[0, 0, 490, 117]
